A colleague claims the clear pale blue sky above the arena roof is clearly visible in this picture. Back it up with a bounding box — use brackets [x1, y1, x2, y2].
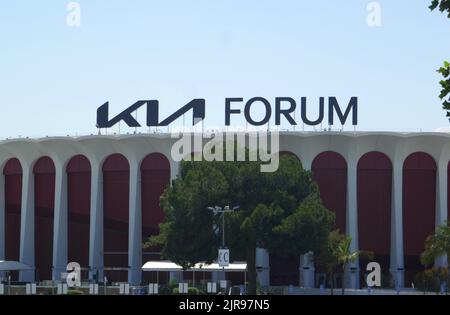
[0, 0, 450, 139]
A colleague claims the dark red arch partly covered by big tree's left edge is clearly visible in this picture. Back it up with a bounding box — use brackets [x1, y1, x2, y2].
[140, 152, 170, 282]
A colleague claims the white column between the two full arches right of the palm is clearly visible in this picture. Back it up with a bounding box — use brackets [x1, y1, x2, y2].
[390, 161, 405, 287]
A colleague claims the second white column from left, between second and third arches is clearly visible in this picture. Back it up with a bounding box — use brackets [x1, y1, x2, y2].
[53, 166, 67, 280]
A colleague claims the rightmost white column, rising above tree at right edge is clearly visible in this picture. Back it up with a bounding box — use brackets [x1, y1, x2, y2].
[435, 163, 448, 267]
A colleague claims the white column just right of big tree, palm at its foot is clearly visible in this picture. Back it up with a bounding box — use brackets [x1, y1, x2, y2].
[345, 156, 359, 289]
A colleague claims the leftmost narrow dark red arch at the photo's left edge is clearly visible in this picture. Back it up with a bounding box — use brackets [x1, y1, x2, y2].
[3, 158, 22, 281]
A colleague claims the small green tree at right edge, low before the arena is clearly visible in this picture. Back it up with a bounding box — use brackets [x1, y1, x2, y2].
[420, 222, 450, 267]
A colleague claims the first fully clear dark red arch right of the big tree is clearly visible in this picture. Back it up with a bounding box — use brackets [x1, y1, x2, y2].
[357, 151, 392, 276]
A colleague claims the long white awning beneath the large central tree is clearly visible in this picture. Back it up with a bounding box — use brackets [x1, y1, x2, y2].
[142, 261, 247, 272]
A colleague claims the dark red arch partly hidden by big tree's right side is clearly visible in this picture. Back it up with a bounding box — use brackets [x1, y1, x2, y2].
[311, 151, 347, 233]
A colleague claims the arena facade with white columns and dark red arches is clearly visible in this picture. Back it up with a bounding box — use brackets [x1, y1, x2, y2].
[0, 132, 450, 287]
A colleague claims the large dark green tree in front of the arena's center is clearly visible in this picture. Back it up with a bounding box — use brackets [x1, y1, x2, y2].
[146, 156, 334, 294]
